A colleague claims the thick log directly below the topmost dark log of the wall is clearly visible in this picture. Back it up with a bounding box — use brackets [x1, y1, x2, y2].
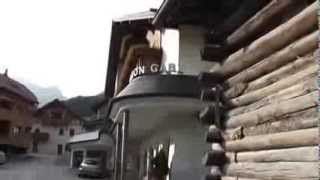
[212, 2, 318, 77]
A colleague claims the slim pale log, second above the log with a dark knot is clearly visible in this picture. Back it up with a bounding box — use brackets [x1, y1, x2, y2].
[226, 77, 318, 117]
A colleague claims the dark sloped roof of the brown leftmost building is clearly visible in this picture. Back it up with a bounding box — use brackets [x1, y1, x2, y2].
[0, 73, 38, 103]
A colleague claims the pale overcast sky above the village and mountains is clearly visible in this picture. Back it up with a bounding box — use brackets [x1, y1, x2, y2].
[0, 0, 162, 97]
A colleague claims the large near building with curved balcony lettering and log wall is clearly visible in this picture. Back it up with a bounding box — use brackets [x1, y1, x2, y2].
[105, 0, 319, 180]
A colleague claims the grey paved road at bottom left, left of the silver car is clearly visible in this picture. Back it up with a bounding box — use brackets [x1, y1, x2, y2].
[0, 155, 109, 180]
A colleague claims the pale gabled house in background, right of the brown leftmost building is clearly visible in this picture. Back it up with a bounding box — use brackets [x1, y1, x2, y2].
[32, 99, 84, 155]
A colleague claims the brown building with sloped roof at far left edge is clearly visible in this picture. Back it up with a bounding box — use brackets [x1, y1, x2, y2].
[0, 70, 38, 153]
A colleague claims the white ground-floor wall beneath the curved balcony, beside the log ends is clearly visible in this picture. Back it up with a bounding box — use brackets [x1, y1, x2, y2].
[140, 118, 210, 180]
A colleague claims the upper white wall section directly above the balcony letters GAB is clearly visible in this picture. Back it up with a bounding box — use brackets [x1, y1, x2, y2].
[161, 25, 219, 75]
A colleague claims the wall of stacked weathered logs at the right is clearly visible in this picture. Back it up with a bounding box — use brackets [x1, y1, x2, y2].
[206, 0, 319, 180]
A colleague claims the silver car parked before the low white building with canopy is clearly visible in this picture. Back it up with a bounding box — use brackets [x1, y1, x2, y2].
[78, 158, 108, 177]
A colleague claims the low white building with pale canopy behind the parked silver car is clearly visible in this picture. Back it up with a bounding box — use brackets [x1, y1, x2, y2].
[67, 98, 115, 172]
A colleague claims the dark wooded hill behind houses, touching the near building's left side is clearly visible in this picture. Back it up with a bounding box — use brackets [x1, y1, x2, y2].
[64, 93, 104, 117]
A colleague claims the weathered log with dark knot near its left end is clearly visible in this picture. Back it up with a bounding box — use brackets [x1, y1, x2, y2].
[223, 107, 318, 141]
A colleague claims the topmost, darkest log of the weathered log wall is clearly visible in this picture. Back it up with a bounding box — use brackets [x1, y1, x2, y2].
[226, 0, 299, 51]
